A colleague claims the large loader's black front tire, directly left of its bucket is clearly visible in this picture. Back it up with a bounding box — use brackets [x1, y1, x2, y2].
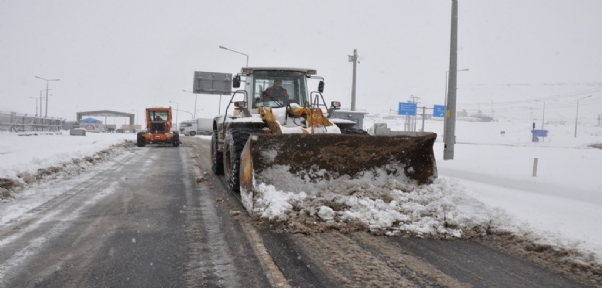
[224, 128, 261, 192]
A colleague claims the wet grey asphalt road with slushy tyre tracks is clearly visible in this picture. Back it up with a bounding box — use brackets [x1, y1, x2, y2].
[0, 137, 592, 287]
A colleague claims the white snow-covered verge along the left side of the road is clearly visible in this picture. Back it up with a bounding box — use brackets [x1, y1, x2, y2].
[0, 131, 135, 199]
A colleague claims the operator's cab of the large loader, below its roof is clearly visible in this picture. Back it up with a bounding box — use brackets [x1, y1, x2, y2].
[246, 70, 308, 109]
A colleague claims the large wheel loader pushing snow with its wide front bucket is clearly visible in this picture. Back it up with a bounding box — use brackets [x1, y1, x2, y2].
[211, 67, 437, 215]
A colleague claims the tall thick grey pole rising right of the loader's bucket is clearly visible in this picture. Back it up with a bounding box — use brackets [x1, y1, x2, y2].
[443, 0, 458, 160]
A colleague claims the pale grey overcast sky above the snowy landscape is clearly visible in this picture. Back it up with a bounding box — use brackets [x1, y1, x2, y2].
[0, 0, 602, 123]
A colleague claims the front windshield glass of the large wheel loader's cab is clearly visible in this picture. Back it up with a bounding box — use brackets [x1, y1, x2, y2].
[253, 71, 307, 108]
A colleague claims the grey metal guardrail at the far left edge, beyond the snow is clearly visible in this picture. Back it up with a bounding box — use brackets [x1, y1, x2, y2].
[0, 111, 65, 133]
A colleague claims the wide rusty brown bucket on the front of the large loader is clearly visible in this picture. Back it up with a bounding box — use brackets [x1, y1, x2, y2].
[240, 133, 437, 215]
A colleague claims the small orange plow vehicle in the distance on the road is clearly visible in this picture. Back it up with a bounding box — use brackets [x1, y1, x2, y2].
[136, 107, 180, 147]
